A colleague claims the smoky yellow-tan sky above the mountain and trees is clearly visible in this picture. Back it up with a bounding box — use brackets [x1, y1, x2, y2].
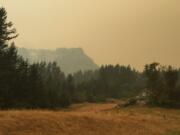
[0, 0, 180, 69]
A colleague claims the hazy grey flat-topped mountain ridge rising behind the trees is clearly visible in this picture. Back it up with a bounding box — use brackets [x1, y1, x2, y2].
[18, 48, 98, 74]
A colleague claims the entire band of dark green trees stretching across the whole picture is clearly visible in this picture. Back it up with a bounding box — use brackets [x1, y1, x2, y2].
[0, 8, 180, 109]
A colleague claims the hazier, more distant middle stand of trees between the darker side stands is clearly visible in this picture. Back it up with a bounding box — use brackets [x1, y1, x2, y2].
[74, 65, 145, 102]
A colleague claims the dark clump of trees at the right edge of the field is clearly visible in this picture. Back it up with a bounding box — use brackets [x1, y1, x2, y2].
[144, 63, 180, 107]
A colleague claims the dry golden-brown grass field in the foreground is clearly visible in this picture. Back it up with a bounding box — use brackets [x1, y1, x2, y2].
[0, 103, 180, 135]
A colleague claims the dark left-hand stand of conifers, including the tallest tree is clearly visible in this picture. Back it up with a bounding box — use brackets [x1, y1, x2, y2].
[0, 8, 73, 108]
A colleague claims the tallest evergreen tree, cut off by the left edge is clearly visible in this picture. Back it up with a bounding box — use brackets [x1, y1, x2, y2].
[0, 8, 18, 107]
